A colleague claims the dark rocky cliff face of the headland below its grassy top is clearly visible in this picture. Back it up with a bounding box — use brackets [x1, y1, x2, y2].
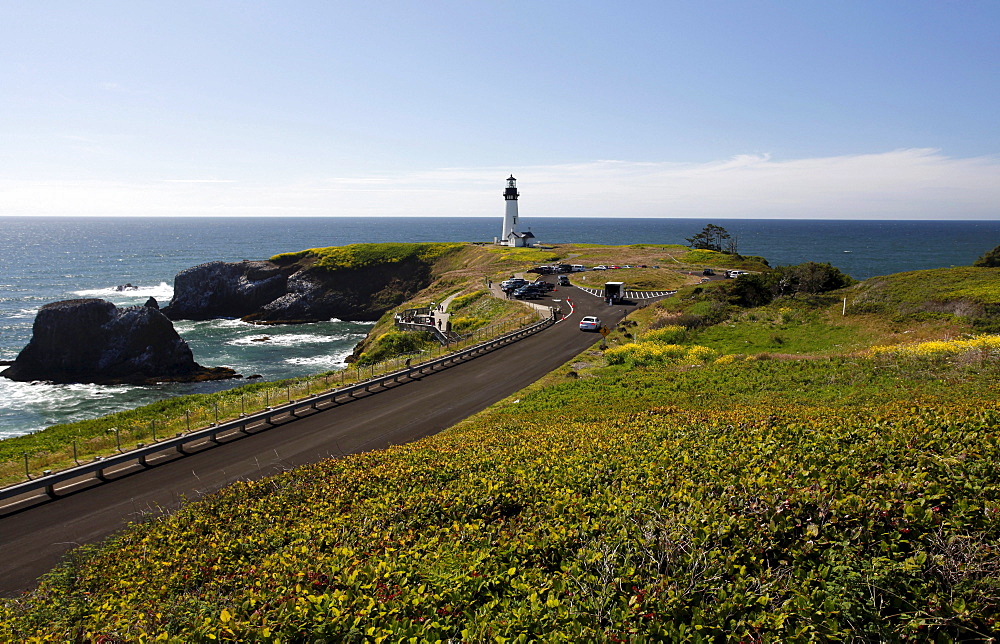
[163, 258, 431, 324]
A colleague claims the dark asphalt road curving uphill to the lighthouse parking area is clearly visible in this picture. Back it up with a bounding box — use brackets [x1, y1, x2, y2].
[0, 289, 632, 596]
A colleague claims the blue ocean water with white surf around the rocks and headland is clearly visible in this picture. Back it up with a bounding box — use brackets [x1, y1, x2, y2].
[0, 216, 1000, 438]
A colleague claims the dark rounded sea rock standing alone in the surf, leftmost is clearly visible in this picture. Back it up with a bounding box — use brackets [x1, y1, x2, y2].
[0, 299, 237, 384]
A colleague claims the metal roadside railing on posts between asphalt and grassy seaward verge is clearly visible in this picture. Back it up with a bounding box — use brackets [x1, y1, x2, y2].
[0, 316, 555, 508]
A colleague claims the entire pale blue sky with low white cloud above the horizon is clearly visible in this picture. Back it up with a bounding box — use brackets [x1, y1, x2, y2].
[0, 0, 1000, 219]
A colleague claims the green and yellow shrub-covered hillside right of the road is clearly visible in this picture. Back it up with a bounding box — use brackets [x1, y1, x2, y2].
[0, 262, 1000, 642]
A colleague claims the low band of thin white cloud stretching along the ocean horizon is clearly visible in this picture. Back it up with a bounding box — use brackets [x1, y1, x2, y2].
[0, 149, 1000, 219]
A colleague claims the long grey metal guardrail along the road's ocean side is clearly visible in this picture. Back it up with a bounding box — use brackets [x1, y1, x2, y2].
[0, 317, 555, 501]
